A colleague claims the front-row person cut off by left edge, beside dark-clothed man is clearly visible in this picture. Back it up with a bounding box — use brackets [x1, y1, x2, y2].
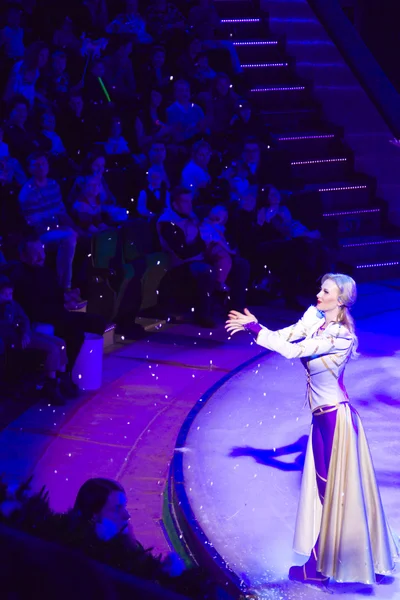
[0, 275, 67, 406]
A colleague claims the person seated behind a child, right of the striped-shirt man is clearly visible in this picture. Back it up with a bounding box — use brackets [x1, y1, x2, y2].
[68, 151, 127, 223]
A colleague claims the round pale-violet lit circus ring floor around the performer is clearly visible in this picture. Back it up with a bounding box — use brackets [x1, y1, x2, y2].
[171, 290, 400, 600]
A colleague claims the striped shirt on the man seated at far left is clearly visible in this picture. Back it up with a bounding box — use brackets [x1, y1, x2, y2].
[19, 179, 67, 234]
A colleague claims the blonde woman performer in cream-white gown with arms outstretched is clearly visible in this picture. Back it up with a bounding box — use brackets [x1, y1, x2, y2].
[226, 273, 399, 586]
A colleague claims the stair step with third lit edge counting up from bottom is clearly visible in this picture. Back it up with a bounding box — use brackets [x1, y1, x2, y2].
[322, 207, 382, 236]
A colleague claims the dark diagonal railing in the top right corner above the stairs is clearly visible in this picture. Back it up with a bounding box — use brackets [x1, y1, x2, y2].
[308, 0, 400, 139]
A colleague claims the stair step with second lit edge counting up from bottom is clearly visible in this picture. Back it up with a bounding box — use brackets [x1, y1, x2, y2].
[339, 238, 400, 265]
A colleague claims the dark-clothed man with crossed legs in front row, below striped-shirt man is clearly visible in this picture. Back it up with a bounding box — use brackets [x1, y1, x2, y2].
[8, 236, 106, 395]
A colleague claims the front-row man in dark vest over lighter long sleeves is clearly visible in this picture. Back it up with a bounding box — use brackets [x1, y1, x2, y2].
[157, 187, 249, 328]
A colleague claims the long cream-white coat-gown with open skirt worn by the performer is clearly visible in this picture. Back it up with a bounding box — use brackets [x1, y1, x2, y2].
[256, 306, 399, 583]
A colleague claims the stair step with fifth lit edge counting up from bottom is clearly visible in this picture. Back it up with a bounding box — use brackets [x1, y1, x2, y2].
[290, 156, 353, 182]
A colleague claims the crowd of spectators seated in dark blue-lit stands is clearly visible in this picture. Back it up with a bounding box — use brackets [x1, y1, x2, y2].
[0, 0, 329, 403]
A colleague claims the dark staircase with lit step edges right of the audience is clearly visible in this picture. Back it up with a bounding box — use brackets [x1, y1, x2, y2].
[215, 0, 400, 282]
